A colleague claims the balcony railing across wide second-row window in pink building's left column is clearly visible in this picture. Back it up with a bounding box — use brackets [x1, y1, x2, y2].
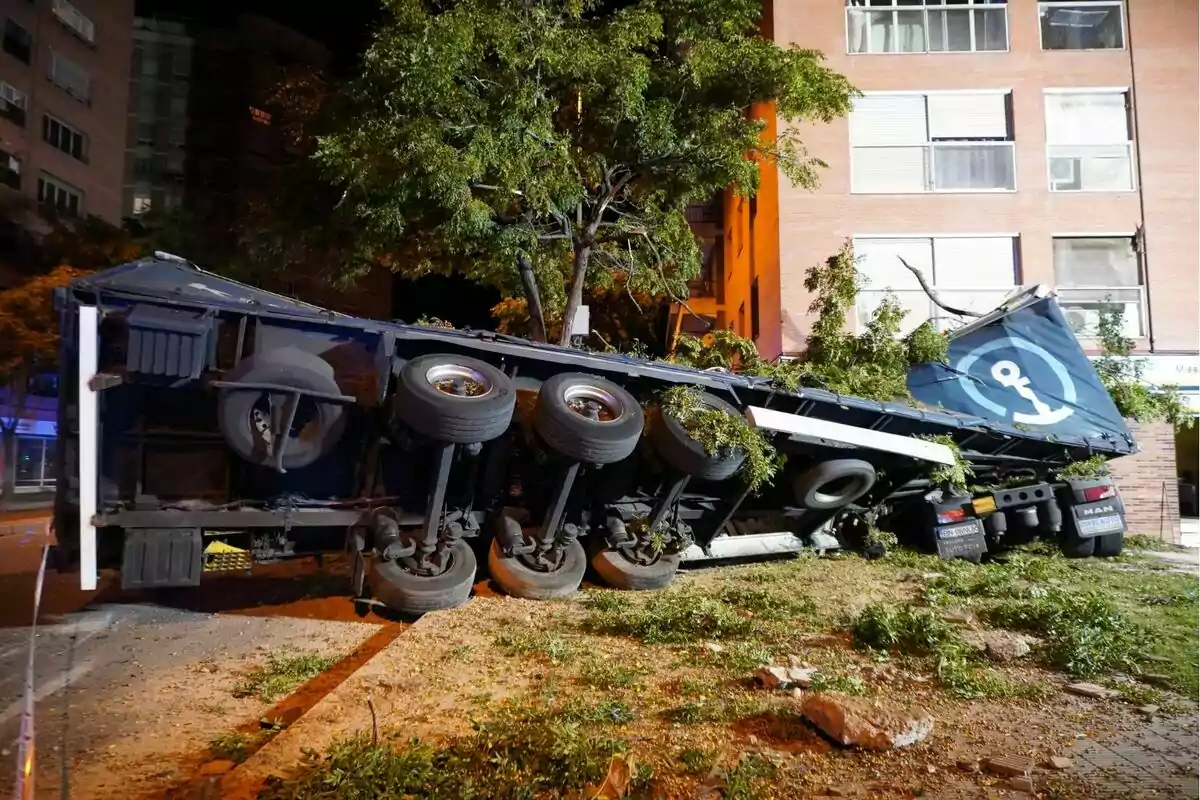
[851, 142, 1016, 194]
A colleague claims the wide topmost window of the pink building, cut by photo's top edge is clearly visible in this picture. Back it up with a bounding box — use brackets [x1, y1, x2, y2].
[846, 0, 1008, 53]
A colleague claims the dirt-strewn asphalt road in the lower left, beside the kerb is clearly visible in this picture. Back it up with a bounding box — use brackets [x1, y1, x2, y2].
[0, 519, 378, 798]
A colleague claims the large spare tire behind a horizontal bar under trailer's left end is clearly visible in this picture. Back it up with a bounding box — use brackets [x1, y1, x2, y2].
[217, 348, 347, 469]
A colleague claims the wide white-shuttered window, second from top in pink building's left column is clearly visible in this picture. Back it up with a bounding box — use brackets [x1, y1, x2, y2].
[850, 92, 1016, 194]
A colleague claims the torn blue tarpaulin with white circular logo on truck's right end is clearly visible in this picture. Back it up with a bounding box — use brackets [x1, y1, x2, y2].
[908, 297, 1129, 439]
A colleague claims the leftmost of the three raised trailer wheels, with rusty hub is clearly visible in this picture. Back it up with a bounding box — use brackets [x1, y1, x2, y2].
[396, 354, 517, 445]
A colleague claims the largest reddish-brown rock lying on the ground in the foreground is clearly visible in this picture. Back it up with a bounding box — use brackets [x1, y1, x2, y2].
[803, 694, 934, 751]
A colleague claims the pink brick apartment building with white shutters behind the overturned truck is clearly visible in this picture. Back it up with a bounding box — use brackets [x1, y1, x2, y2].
[691, 0, 1200, 530]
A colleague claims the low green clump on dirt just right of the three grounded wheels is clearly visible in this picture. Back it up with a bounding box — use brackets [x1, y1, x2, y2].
[586, 588, 754, 644]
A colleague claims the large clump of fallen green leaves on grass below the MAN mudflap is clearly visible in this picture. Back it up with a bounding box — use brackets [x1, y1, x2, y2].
[984, 588, 1147, 678]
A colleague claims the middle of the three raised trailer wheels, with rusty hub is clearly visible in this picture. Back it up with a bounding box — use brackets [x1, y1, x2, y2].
[534, 372, 646, 464]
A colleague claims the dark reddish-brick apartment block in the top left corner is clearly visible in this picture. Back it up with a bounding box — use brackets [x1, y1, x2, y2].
[0, 0, 133, 224]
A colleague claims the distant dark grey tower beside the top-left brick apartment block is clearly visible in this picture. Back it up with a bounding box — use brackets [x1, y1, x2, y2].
[121, 17, 192, 217]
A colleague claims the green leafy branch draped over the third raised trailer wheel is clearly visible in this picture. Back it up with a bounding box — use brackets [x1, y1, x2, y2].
[659, 384, 780, 492]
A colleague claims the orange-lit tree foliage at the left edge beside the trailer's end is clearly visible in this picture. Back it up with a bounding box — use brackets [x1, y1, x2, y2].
[0, 266, 85, 501]
